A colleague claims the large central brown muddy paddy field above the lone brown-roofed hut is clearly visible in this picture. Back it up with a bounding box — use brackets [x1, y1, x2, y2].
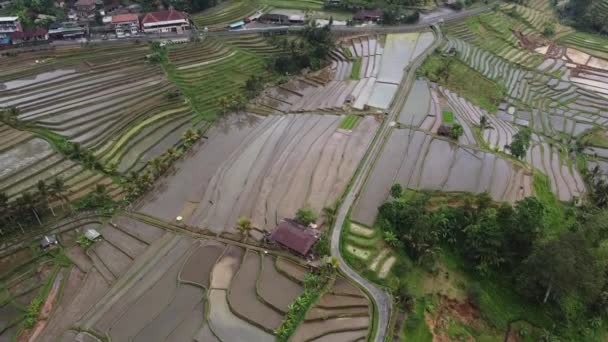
[138, 114, 379, 232]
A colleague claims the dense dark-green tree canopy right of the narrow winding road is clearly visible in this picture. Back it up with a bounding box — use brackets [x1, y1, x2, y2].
[378, 187, 608, 322]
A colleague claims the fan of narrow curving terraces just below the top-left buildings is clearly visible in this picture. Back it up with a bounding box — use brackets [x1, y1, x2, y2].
[0, 44, 192, 178]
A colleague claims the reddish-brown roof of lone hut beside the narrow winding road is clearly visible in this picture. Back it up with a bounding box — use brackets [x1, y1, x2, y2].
[270, 219, 319, 255]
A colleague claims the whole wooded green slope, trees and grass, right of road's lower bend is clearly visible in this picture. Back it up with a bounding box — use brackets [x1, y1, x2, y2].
[372, 186, 608, 341]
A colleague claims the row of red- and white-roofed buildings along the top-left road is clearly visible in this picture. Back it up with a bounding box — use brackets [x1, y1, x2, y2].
[0, 6, 190, 47]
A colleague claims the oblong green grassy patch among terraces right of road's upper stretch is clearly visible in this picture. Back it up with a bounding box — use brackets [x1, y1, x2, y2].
[418, 53, 506, 113]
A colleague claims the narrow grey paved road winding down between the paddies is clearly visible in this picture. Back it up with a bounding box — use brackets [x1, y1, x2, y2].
[331, 26, 443, 342]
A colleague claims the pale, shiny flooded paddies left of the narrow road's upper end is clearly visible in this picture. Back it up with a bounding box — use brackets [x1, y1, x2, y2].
[254, 32, 434, 114]
